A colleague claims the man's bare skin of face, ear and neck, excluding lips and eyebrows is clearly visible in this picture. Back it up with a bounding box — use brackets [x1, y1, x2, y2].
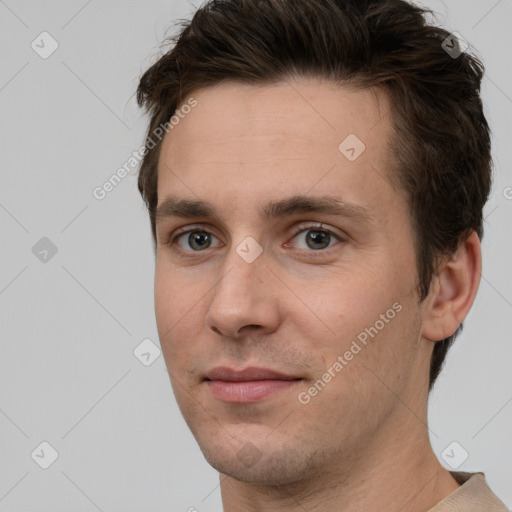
[155, 78, 481, 512]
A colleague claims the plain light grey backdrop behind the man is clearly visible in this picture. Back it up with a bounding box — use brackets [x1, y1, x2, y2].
[0, 0, 512, 512]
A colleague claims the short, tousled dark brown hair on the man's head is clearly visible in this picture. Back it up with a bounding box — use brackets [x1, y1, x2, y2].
[137, 0, 492, 389]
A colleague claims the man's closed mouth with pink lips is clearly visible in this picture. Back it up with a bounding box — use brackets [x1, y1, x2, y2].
[205, 367, 303, 404]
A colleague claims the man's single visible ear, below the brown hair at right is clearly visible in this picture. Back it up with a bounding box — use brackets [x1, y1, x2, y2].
[422, 231, 482, 341]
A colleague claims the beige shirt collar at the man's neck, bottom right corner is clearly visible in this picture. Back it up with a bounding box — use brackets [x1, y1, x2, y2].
[428, 471, 508, 512]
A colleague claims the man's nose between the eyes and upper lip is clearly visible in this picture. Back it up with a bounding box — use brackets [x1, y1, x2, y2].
[206, 247, 280, 339]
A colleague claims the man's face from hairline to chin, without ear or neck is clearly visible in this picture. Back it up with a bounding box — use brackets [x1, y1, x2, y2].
[155, 79, 431, 484]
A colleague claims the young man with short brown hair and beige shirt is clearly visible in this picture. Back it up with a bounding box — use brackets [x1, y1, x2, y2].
[134, 0, 506, 512]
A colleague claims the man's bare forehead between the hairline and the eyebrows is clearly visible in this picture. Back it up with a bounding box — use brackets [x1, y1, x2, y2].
[158, 79, 400, 220]
